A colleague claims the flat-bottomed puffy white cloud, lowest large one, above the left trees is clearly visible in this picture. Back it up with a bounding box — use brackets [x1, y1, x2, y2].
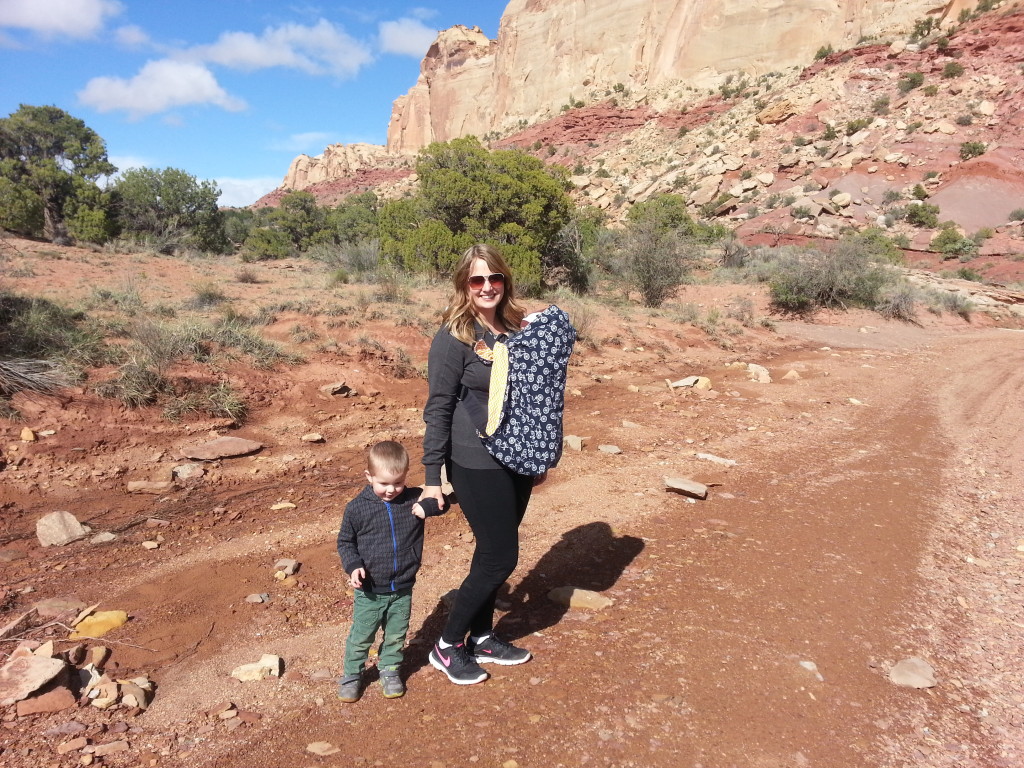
[78, 58, 246, 118]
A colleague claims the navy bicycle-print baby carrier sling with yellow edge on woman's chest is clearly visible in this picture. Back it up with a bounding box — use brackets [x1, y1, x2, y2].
[465, 304, 577, 477]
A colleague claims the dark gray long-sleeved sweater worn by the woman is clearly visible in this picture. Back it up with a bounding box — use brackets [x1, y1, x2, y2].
[423, 326, 512, 485]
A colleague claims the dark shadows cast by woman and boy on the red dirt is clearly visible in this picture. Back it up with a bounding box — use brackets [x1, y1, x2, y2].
[404, 522, 643, 675]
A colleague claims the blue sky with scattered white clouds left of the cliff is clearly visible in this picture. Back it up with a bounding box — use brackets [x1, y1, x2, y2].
[0, 0, 507, 205]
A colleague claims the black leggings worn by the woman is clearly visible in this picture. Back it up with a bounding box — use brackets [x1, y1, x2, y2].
[441, 464, 534, 644]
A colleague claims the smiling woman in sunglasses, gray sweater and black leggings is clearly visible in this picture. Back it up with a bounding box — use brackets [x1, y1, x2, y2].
[420, 245, 546, 685]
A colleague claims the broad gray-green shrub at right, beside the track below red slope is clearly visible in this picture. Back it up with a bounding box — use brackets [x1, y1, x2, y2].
[768, 241, 892, 313]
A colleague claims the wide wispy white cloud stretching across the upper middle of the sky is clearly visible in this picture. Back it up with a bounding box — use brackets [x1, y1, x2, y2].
[188, 18, 373, 78]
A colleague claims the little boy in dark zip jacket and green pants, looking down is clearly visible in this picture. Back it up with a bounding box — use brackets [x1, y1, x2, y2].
[338, 440, 441, 701]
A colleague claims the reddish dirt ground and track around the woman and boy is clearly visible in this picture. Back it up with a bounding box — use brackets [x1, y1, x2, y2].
[0, 237, 1024, 768]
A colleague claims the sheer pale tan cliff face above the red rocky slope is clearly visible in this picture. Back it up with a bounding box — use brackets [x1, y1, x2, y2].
[387, 0, 976, 152]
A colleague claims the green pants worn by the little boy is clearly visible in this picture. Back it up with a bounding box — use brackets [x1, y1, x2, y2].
[344, 587, 413, 677]
